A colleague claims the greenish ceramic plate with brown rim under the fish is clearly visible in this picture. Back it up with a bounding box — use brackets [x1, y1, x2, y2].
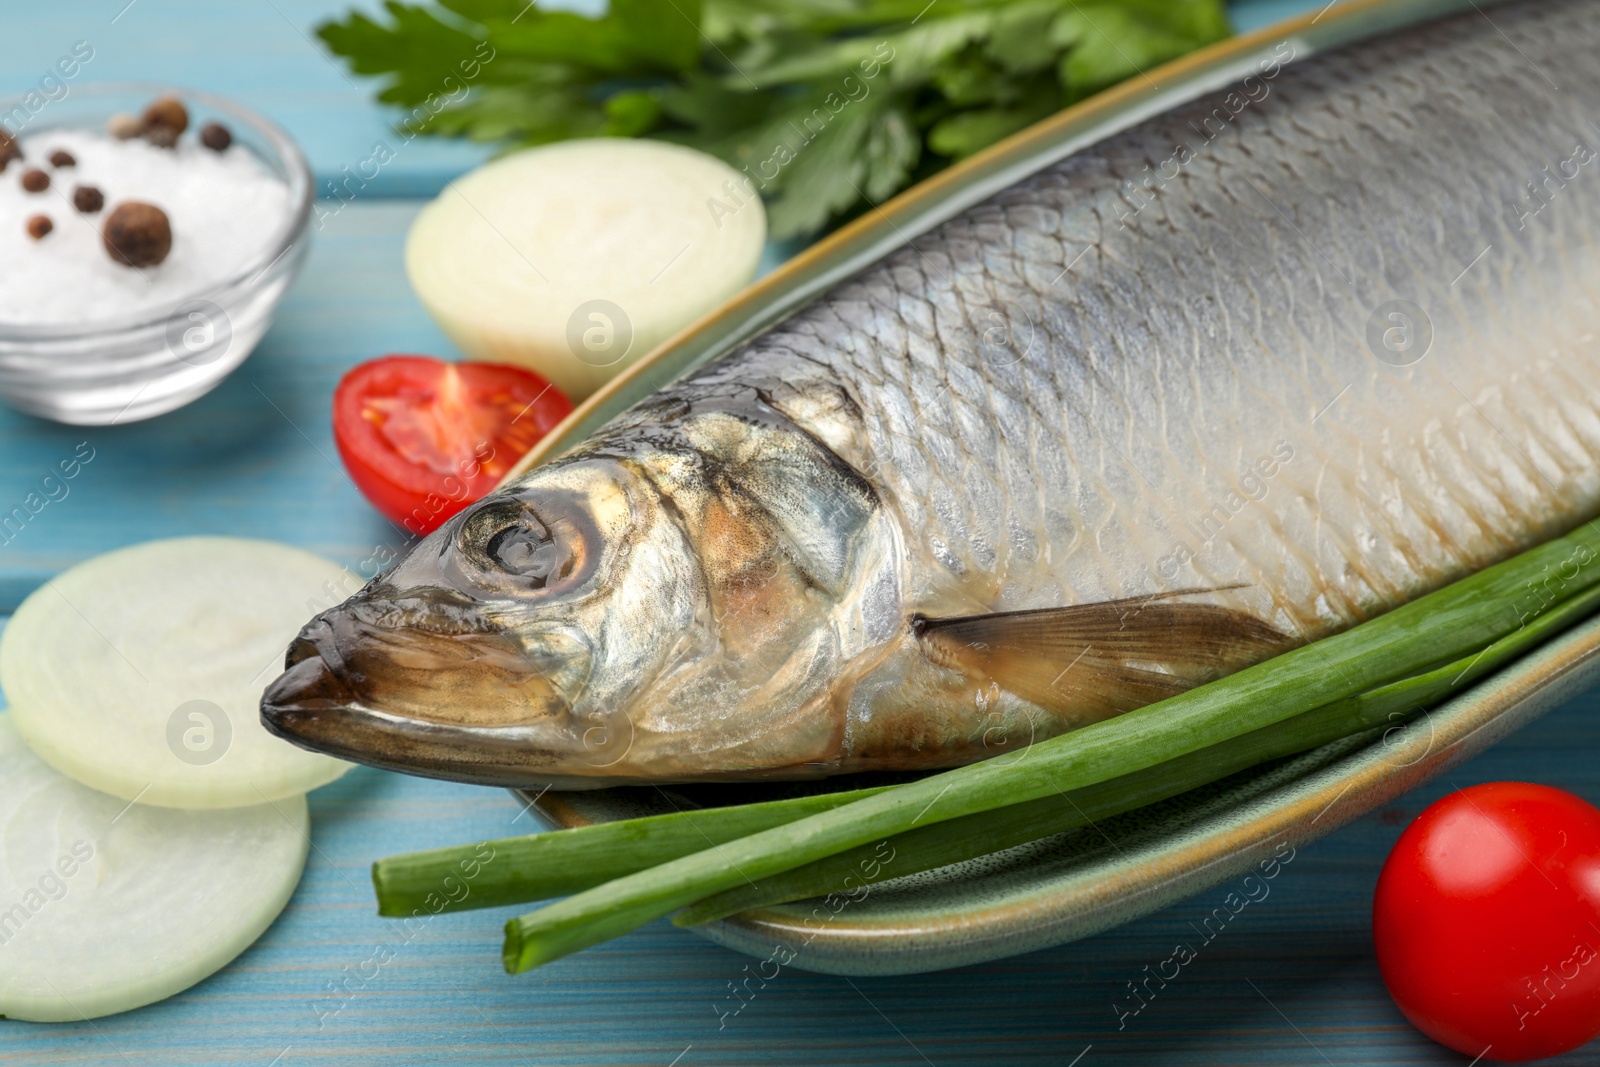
[514, 0, 1600, 974]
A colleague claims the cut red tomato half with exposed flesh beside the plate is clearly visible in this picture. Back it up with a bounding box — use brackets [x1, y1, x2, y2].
[333, 355, 573, 536]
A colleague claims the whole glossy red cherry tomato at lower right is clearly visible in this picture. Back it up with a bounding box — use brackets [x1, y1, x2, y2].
[1373, 782, 1600, 1061]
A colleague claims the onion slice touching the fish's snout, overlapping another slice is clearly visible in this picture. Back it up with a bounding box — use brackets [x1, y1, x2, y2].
[0, 537, 357, 808]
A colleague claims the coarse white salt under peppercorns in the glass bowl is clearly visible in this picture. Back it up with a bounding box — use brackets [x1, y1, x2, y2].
[0, 130, 290, 325]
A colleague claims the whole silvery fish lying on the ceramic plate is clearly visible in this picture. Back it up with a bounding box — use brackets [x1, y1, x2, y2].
[262, 0, 1600, 789]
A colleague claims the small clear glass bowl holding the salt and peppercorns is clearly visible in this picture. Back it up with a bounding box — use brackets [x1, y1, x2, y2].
[0, 82, 314, 426]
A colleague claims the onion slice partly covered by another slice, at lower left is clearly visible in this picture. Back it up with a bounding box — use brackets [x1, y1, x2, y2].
[0, 715, 310, 1022]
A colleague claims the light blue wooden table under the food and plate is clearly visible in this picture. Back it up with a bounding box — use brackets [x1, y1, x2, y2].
[0, 0, 1600, 1067]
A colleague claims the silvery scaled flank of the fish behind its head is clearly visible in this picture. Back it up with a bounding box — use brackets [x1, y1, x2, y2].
[646, 3, 1600, 638]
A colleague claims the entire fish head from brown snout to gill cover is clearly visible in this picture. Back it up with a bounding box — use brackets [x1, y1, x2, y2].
[261, 390, 896, 789]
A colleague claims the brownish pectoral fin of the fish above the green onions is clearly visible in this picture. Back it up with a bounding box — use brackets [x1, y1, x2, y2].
[912, 589, 1288, 720]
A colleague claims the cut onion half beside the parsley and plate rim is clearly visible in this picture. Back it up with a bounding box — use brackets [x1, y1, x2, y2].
[405, 138, 766, 402]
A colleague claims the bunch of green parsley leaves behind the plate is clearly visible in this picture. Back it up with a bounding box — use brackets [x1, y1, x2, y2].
[317, 0, 1229, 240]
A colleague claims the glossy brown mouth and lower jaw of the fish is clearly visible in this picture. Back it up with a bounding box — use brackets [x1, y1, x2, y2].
[261, 605, 613, 789]
